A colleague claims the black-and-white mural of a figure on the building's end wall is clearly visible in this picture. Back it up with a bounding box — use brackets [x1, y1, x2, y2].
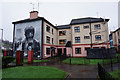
[14, 20, 42, 57]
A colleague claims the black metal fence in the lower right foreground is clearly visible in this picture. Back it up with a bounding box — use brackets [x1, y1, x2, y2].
[98, 63, 115, 80]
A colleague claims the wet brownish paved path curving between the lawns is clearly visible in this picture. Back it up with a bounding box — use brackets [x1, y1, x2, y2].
[24, 60, 98, 80]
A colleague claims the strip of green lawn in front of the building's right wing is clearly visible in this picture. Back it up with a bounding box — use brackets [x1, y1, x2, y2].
[63, 54, 120, 65]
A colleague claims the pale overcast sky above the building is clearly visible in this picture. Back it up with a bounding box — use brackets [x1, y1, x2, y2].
[0, 0, 118, 41]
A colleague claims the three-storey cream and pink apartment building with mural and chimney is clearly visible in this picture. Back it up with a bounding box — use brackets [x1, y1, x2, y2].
[13, 11, 109, 58]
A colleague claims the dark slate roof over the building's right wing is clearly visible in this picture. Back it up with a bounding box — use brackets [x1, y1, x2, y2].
[70, 17, 109, 25]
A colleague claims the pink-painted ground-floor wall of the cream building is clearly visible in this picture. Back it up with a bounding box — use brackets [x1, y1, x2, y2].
[43, 44, 110, 58]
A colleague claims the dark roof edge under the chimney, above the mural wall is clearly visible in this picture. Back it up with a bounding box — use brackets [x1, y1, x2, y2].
[12, 17, 56, 28]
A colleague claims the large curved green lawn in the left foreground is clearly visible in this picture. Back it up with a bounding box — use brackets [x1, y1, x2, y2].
[2, 66, 67, 79]
